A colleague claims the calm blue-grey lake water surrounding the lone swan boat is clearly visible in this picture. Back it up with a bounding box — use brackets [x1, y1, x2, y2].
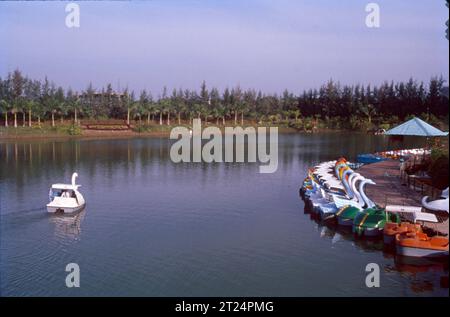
[0, 133, 448, 296]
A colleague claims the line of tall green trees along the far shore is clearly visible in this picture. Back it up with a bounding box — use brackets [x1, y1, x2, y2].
[0, 69, 448, 127]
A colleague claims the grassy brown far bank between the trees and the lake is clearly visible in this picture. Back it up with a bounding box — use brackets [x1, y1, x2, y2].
[0, 118, 448, 139]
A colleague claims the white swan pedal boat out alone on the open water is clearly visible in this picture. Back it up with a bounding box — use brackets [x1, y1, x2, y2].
[47, 173, 86, 214]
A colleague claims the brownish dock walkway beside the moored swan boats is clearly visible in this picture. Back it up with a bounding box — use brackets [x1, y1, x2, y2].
[358, 160, 449, 235]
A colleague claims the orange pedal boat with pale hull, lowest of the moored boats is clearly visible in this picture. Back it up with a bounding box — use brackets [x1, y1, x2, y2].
[395, 232, 448, 257]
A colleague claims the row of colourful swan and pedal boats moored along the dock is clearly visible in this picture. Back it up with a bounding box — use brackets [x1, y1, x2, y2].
[300, 158, 449, 257]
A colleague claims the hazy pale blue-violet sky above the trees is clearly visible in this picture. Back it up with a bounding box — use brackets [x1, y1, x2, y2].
[0, 0, 449, 95]
